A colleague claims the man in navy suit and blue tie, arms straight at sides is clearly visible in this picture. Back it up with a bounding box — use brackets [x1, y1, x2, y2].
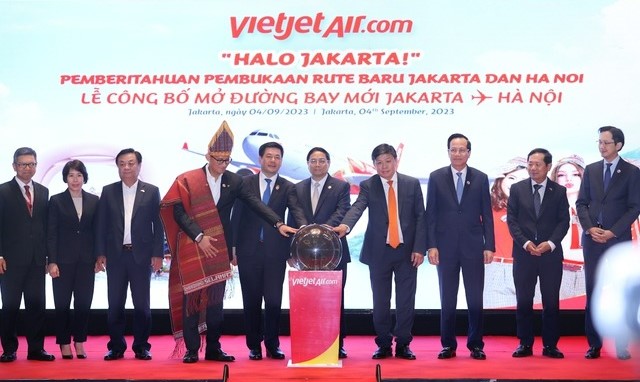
[426, 134, 495, 360]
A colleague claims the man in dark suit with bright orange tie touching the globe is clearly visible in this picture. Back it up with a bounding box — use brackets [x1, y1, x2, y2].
[334, 144, 427, 360]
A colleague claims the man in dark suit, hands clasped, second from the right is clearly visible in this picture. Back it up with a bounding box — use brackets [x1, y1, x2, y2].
[507, 148, 569, 358]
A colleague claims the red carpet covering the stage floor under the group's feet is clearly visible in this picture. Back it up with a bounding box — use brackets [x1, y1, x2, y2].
[0, 336, 640, 382]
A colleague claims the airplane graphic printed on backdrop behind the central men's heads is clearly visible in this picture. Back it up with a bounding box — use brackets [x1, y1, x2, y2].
[182, 129, 426, 194]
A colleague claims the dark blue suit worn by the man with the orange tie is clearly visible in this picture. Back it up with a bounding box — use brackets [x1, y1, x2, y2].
[341, 174, 427, 347]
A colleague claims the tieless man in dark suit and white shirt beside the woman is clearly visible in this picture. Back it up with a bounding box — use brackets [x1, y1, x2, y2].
[96, 149, 164, 361]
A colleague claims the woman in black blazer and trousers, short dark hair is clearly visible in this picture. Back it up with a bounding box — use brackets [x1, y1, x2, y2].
[47, 160, 98, 359]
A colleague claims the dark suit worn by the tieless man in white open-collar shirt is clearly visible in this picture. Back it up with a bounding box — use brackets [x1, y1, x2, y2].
[96, 180, 164, 352]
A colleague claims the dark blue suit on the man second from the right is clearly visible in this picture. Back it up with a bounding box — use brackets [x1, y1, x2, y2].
[507, 179, 569, 348]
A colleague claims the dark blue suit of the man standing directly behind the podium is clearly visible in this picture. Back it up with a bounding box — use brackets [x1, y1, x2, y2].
[287, 175, 351, 346]
